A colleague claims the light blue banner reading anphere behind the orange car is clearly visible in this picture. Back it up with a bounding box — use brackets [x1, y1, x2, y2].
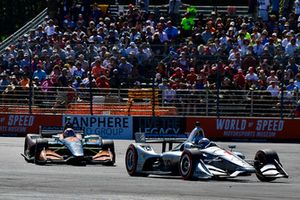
[63, 115, 132, 139]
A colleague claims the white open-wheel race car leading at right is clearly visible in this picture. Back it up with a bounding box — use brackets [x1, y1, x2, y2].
[125, 122, 288, 182]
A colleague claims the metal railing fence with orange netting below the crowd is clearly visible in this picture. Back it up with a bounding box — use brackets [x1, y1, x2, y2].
[0, 87, 299, 117]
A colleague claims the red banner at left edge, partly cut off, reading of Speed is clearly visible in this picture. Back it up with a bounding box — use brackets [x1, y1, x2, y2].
[0, 114, 62, 136]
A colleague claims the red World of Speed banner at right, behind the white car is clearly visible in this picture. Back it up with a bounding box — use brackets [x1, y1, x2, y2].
[186, 117, 300, 141]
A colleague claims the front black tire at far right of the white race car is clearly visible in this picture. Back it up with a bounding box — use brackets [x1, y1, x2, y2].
[254, 149, 281, 182]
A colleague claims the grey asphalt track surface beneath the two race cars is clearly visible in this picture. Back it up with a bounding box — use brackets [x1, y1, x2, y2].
[0, 137, 300, 200]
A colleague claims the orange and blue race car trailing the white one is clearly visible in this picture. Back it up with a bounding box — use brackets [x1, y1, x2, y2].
[22, 128, 116, 165]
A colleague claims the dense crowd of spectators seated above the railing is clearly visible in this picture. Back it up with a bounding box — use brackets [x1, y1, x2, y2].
[0, 1, 300, 114]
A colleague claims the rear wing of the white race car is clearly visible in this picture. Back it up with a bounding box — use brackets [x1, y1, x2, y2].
[135, 132, 187, 152]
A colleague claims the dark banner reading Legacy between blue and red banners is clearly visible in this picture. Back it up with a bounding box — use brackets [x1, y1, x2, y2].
[133, 117, 187, 138]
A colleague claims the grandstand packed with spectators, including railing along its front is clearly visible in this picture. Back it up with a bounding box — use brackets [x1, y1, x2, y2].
[0, 1, 300, 117]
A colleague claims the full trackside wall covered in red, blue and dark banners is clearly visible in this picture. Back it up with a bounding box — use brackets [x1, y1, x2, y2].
[0, 114, 300, 142]
